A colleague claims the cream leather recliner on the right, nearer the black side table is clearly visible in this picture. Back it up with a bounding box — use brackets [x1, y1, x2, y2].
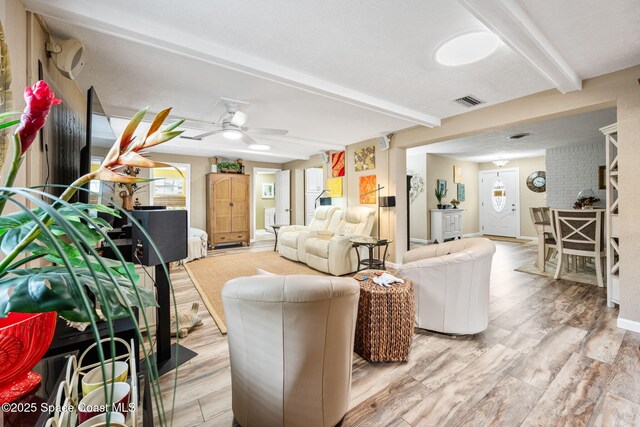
[305, 206, 375, 276]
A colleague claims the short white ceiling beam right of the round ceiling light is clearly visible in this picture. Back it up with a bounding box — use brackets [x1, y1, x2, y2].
[458, 0, 582, 93]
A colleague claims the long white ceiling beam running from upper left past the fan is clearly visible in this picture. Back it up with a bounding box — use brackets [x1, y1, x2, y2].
[24, 0, 440, 127]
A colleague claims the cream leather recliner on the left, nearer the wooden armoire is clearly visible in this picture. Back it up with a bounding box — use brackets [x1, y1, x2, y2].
[278, 206, 340, 262]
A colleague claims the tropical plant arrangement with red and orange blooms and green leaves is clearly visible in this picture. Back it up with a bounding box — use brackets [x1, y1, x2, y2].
[0, 81, 183, 424]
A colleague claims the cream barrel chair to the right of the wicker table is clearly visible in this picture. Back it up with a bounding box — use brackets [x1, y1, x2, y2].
[397, 237, 496, 335]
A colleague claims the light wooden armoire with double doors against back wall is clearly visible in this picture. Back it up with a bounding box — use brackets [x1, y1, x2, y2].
[207, 173, 251, 246]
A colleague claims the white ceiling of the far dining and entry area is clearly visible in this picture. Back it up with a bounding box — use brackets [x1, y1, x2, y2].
[407, 108, 616, 162]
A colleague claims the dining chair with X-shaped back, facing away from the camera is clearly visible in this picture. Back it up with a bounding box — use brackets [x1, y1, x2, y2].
[551, 209, 606, 287]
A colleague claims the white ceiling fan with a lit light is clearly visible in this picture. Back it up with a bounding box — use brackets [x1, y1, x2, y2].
[180, 98, 289, 150]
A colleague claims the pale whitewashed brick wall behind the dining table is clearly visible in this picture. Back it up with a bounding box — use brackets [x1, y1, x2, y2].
[545, 142, 606, 208]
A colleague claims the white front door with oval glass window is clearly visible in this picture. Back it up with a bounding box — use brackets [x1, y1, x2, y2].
[480, 168, 520, 237]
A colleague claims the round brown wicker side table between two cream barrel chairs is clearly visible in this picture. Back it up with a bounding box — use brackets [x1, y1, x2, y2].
[354, 270, 415, 362]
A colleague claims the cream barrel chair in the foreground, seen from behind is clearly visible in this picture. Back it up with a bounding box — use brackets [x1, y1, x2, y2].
[222, 275, 360, 427]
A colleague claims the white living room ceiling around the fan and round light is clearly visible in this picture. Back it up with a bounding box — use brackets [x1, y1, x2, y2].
[24, 0, 640, 162]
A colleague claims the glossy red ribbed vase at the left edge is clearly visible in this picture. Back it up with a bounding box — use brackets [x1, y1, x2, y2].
[0, 312, 58, 404]
